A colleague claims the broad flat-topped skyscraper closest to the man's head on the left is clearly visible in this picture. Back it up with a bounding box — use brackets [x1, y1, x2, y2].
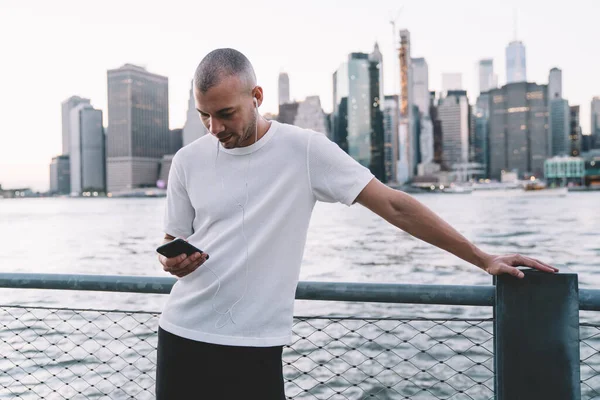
[107, 64, 169, 192]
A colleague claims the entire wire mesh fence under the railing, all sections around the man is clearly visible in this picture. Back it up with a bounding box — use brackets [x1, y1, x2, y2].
[0, 306, 600, 400]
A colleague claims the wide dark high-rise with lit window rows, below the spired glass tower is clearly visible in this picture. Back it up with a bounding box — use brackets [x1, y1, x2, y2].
[489, 82, 550, 179]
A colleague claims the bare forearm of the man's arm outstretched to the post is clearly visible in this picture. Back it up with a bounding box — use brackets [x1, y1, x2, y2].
[386, 191, 490, 268]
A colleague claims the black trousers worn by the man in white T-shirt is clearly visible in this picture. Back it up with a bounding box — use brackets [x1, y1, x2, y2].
[156, 327, 285, 400]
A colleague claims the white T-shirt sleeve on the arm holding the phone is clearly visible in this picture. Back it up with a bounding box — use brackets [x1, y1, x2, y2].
[164, 157, 196, 238]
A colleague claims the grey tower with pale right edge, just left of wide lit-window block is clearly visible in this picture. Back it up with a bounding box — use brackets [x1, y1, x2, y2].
[437, 90, 470, 169]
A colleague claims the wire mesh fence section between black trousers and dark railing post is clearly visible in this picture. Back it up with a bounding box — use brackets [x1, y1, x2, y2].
[284, 318, 494, 399]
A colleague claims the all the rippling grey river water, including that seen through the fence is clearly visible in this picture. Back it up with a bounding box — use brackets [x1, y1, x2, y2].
[0, 192, 600, 399]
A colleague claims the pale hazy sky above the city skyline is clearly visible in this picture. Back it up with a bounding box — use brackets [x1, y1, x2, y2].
[0, 0, 600, 191]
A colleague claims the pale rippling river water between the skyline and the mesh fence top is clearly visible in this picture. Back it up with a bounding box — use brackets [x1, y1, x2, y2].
[0, 192, 600, 313]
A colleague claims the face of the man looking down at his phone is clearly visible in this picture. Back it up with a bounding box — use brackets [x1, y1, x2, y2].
[194, 76, 256, 149]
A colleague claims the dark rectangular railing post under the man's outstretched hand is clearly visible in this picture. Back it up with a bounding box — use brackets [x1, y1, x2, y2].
[494, 270, 581, 400]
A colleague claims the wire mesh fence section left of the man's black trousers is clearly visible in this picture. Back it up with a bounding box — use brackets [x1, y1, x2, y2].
[0, 306, 158, 399]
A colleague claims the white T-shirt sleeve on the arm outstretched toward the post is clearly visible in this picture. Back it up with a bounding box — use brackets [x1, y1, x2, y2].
[307, 133, 374, 206]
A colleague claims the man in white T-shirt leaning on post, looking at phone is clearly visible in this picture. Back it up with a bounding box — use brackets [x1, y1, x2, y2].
[156, 49, 558, 400]
